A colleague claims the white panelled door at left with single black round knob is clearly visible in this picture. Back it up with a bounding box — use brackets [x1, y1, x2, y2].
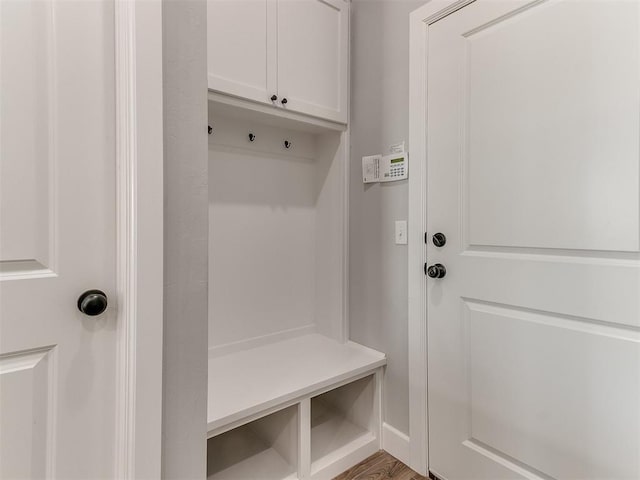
[0, 0, 116, 479]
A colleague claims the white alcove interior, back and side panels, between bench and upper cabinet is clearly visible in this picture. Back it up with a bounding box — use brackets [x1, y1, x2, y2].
[209, 114, 346, 355]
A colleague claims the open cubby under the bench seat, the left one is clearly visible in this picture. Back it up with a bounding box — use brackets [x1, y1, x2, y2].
[207, 405, 298, 480]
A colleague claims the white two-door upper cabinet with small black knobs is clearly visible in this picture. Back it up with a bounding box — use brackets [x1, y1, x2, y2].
[208, 0, 349, 123]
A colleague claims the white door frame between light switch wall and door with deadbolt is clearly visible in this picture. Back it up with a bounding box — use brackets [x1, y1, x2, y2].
[408, 0, 474, 475]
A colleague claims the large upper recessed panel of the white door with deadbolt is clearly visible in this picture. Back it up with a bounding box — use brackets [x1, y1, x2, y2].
[464, 1, 640, 251]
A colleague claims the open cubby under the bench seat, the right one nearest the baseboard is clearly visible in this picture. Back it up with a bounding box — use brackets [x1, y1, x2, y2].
[311, 375, 379, 472]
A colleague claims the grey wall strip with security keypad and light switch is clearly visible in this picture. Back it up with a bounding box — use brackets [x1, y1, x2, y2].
[349, 0, 426, 434]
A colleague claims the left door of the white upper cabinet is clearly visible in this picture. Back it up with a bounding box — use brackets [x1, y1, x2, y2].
[207, 0, 277, 103]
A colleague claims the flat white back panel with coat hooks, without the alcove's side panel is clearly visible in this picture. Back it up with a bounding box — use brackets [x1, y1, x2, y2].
[209, 116, 318, 347]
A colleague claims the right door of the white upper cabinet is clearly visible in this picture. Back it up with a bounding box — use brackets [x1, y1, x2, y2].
[278, 0, 349, 123]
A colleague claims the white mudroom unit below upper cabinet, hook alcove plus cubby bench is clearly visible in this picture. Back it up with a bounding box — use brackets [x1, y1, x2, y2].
[207, 92, 386, 480]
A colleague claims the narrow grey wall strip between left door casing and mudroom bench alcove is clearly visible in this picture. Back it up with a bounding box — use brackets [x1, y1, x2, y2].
[162, 0, 208, 479]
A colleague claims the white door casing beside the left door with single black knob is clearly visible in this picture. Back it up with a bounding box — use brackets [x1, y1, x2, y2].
[114, 0, 163, 479]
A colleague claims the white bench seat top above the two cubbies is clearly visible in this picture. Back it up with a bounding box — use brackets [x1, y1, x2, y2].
[207, 334, 386, 437]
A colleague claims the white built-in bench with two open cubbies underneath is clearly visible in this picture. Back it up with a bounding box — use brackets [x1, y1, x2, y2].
[207, 334, 386, 479]
